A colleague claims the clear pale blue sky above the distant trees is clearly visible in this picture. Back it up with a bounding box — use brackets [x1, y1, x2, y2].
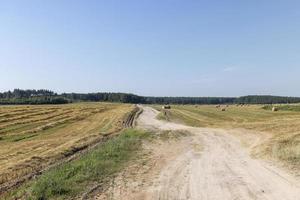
[0, 0, 300, 96]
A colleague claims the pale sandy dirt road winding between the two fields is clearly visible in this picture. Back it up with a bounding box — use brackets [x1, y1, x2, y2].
[95, 107, 300, 200]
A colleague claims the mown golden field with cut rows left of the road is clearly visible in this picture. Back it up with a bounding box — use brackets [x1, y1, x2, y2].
[0, 103, 134, 188]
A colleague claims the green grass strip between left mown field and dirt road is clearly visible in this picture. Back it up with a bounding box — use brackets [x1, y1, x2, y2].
[7, 129, 148, 200]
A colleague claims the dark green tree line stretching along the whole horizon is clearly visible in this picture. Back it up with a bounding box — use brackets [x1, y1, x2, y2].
[0, 89, 300, 104]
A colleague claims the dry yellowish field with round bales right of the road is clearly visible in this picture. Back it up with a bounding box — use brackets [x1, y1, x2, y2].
[155, 105, 300, 169]
